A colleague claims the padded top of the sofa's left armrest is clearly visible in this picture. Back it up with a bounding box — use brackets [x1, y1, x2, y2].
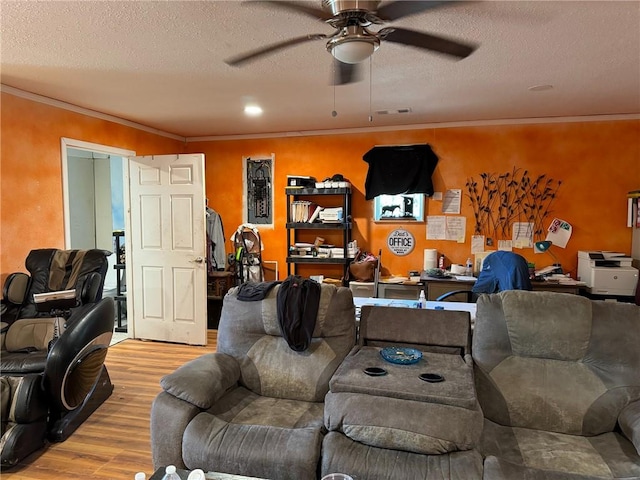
[160, 353, 240, 410]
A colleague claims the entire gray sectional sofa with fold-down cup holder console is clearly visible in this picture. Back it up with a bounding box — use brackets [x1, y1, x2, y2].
[151, 285, 640, 480]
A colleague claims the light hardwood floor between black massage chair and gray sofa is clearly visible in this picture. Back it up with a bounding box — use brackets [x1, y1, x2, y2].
[1, 330, 217, 480]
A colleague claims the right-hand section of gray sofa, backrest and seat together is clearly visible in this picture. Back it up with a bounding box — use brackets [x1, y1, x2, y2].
[472, 290, 640, 480]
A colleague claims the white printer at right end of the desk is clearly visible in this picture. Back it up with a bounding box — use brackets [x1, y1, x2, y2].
[578, 251, 638, 296]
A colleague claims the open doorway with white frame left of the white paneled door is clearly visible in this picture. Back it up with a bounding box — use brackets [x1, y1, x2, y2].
[62, 138, 135, 337]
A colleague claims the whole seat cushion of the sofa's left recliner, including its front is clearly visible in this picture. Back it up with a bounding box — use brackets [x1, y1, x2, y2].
[182, 386, 325, 480]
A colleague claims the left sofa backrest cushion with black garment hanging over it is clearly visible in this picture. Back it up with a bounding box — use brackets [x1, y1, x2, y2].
[217, 284, 355, 402]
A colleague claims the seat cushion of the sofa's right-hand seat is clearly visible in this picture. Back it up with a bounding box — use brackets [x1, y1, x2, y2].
[479, 420, 640, 479]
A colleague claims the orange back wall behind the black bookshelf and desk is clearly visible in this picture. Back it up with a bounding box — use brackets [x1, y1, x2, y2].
[188, 120, 640, 278]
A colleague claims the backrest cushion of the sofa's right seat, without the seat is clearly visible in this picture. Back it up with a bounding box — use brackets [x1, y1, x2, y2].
[472, 291, 640, 435]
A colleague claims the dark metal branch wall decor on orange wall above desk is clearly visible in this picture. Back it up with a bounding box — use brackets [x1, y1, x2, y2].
[466, 168, 562, 242]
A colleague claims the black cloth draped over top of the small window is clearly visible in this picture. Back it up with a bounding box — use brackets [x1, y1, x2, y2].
[362, 144, 438, 200]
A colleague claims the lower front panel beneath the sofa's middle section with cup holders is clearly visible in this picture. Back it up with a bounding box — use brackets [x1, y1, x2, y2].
[321, 432, 482, 480]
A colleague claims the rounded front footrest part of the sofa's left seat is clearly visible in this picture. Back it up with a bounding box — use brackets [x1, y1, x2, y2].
[182, 412, 323, 480]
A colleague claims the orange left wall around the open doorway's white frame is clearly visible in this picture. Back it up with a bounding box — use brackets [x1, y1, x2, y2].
[0, 93, 184, 282]
